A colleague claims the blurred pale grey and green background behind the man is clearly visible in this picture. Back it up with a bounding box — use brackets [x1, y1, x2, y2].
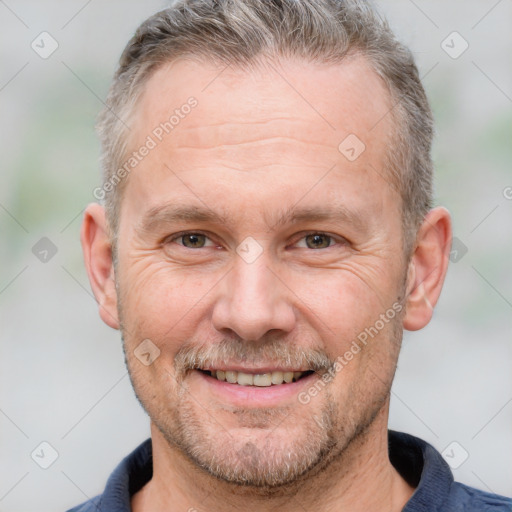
[0, 0, 512, 512]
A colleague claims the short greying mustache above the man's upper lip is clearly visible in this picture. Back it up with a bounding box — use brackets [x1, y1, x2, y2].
[174, 338, 336, 378]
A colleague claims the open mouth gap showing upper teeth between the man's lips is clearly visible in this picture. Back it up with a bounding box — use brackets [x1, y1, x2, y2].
[197, 368, 314, 387]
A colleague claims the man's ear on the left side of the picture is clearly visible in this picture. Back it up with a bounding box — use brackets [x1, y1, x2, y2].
[80, 203, 119, 329]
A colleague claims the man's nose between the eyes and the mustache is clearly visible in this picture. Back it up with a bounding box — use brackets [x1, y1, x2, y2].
[212, 255, 296, 341]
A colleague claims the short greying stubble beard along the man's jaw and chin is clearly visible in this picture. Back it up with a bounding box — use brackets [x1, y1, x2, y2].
[118, 280, 402, 496]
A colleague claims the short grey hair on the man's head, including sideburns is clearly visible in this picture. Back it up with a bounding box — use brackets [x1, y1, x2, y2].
[98, 0, 433, 255]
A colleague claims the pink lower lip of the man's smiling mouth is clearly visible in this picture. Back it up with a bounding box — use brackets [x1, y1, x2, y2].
[189, 369, 318, 408]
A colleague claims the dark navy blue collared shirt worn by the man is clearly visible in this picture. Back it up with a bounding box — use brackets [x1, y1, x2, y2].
[68, 430, 512, 512]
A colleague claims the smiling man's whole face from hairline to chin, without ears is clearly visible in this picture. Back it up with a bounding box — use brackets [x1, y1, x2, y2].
[116, 58, 405, 487]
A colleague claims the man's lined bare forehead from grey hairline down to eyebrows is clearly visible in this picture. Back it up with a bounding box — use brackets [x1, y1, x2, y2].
[123, 56, 396, 227]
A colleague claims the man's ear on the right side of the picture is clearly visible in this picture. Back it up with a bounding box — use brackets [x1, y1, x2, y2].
[403, 207, 452, 331]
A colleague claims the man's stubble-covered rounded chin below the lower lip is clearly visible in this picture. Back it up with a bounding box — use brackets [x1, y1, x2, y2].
[153, 394, 339, 492]
